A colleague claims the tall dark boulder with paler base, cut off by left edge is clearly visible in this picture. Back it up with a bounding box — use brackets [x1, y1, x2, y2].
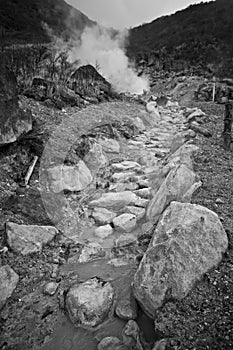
[0, 62, 32, 146]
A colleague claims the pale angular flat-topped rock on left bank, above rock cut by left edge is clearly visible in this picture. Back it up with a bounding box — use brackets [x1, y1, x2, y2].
[6, 222, 58, 255]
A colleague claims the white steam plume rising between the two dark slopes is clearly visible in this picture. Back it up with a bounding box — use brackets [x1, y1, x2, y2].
[69, 26, 149, 94]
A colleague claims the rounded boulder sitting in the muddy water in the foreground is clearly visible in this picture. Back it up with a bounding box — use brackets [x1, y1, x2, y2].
[66, 277, 114, 327]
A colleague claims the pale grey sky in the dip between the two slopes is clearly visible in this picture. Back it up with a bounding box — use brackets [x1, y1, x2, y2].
[65, 0, 213, 29]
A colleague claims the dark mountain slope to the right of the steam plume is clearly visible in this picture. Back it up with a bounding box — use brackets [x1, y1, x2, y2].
[128, 0, 233, 76]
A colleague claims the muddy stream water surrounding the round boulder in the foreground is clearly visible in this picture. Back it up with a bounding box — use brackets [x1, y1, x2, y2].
[40, 259, 157, 350]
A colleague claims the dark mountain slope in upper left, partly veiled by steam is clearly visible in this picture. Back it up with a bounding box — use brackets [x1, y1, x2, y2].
[0, 0, 95, 43]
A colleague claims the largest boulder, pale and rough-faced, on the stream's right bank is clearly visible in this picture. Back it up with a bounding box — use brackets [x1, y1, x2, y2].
[133, 202, 228, 317]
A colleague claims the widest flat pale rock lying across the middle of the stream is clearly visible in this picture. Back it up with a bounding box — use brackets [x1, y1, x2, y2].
[89, 191, 140, 210]
